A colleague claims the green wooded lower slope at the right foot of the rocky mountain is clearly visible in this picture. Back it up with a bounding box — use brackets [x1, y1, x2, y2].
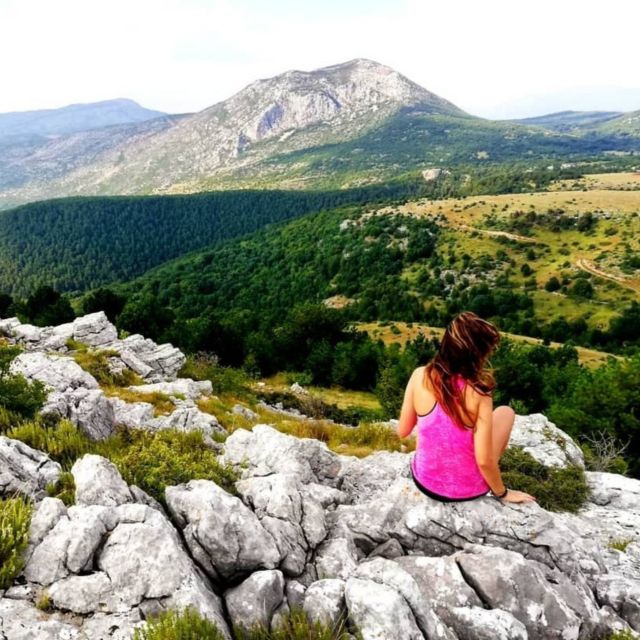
[191, 109, 640, 192]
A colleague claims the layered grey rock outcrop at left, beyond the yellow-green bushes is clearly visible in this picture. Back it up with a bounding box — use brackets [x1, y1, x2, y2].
[0, 312, 226, 440]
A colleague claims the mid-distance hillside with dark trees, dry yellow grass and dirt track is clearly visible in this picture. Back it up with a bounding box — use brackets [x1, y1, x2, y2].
[109, 171, 640, 356]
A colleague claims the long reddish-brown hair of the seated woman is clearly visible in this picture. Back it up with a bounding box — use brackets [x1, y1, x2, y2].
[424, 311, 500, 427]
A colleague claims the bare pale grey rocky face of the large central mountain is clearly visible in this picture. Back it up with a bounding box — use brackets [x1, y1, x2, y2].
[2, 59, 465, 199]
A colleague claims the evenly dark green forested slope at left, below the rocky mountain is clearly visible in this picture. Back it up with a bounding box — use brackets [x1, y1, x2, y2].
[0, 181, 430, 295]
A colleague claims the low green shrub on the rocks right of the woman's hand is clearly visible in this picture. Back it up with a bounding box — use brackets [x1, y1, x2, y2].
[500, 447, 589, 513]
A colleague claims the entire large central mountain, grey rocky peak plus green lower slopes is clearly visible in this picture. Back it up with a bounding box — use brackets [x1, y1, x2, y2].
[0, 59, 638, 208]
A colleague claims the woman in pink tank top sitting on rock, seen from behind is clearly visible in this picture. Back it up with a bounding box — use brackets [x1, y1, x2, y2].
[398, 311, 535, 502]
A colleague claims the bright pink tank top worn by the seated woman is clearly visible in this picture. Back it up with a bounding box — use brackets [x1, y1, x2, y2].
[411, 377, 489, 499]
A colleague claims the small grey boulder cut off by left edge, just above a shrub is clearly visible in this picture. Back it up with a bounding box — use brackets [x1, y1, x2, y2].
[0, 436, 61, 500]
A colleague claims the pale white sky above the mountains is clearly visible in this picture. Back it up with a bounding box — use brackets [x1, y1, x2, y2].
[0, 0, 640, 118]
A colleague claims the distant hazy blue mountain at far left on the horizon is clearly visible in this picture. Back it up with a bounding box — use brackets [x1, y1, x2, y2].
[0, 98, 166, 138]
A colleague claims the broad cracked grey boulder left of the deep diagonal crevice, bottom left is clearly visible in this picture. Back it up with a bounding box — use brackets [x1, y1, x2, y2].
[16, 472, 230, 639]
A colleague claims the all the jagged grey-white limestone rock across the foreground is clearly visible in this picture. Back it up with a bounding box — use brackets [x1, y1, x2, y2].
[0, 314, 640, 640]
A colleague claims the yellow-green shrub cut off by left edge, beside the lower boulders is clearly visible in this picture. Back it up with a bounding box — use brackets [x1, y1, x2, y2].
[0, 498, 31, 589]
